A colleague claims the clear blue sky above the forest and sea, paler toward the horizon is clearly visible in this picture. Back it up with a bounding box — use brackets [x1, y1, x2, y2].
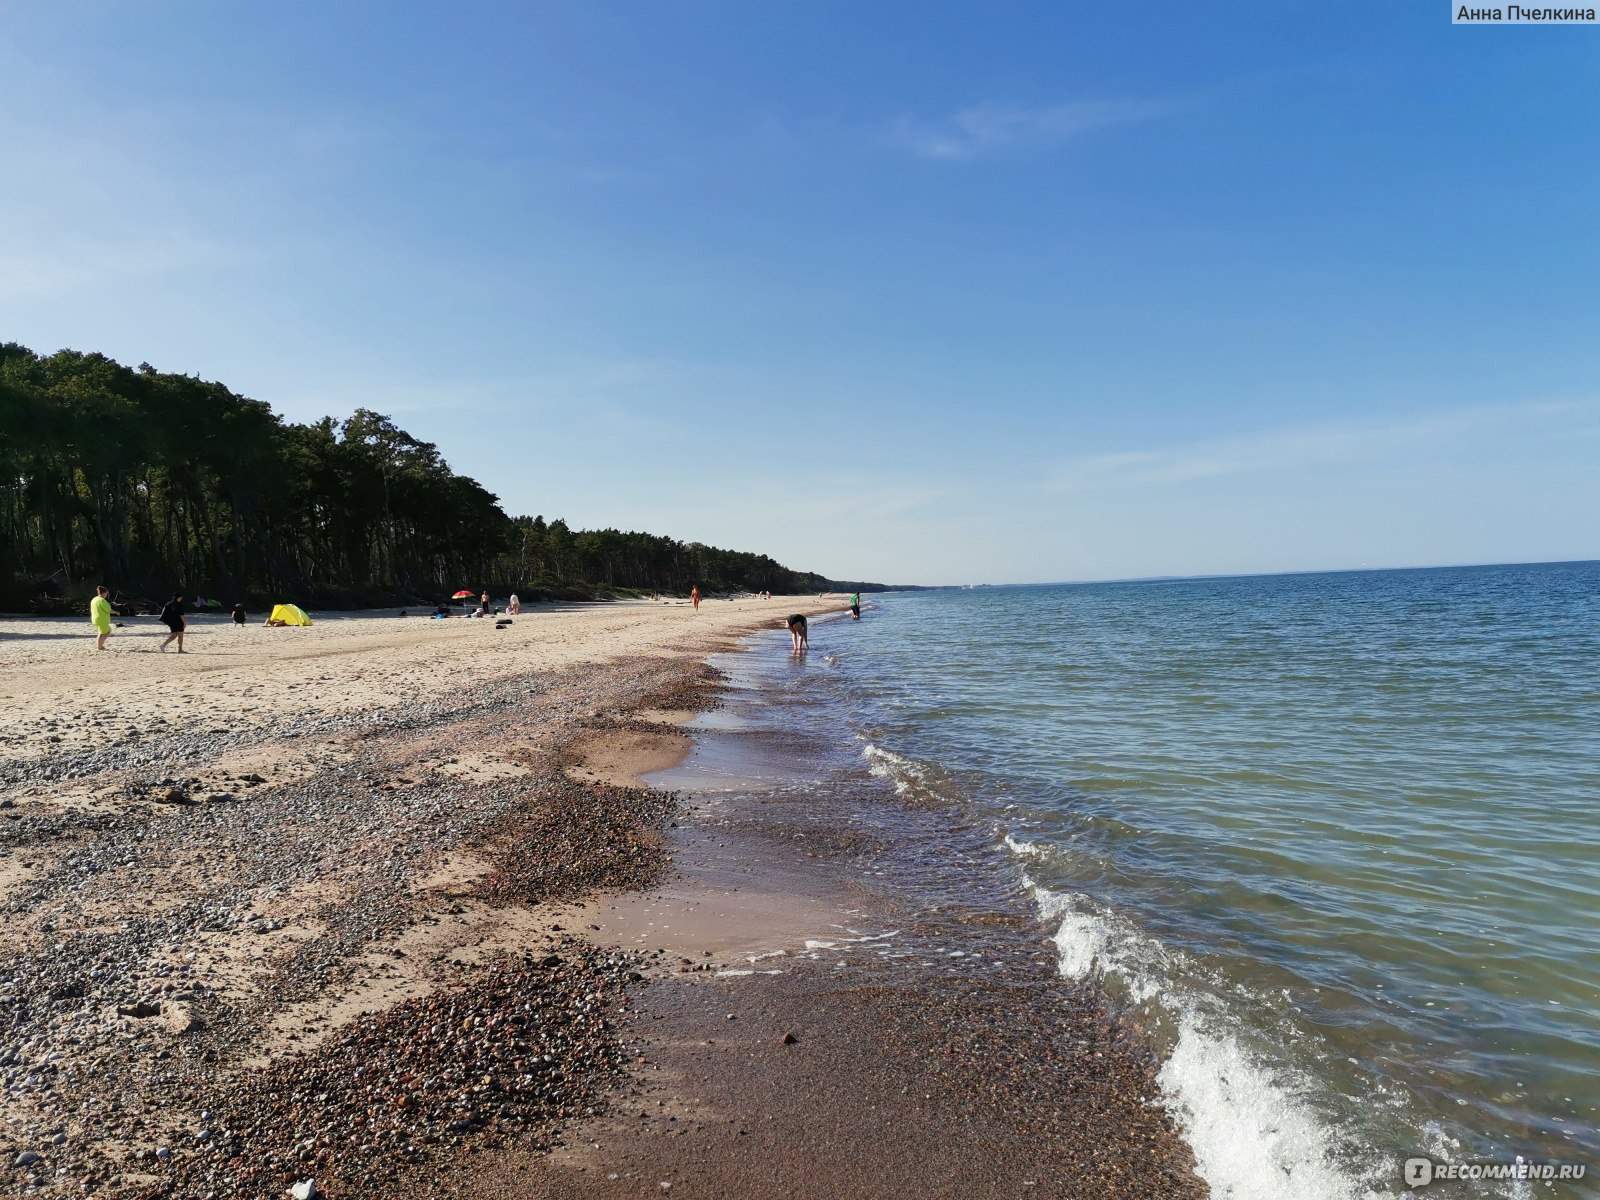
[0, 0, 1600, 582]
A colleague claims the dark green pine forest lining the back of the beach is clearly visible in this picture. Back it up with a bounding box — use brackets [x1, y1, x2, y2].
[0, 342, 878, 611]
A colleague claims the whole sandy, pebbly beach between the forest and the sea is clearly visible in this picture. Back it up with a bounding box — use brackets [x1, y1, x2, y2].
[0, 597, 1203, 1200]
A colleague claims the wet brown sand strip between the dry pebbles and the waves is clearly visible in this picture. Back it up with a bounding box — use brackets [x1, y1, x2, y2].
[450, 634, 1206, 1200]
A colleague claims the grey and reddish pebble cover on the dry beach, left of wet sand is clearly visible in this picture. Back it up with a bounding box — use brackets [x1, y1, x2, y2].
[0, 662, 726, 1200]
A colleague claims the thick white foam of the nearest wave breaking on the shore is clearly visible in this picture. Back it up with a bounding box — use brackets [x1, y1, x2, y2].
[1008, 864, 1394, 1200]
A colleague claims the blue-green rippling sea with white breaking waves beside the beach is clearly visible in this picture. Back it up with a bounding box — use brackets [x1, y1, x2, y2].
[665, 562, 1600, 1200]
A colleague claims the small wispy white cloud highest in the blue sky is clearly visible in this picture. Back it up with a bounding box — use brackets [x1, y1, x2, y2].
[890, 101, 1171, 162]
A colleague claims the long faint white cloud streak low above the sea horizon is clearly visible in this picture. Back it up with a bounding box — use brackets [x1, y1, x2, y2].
[1042, 400, 1600, 493]
